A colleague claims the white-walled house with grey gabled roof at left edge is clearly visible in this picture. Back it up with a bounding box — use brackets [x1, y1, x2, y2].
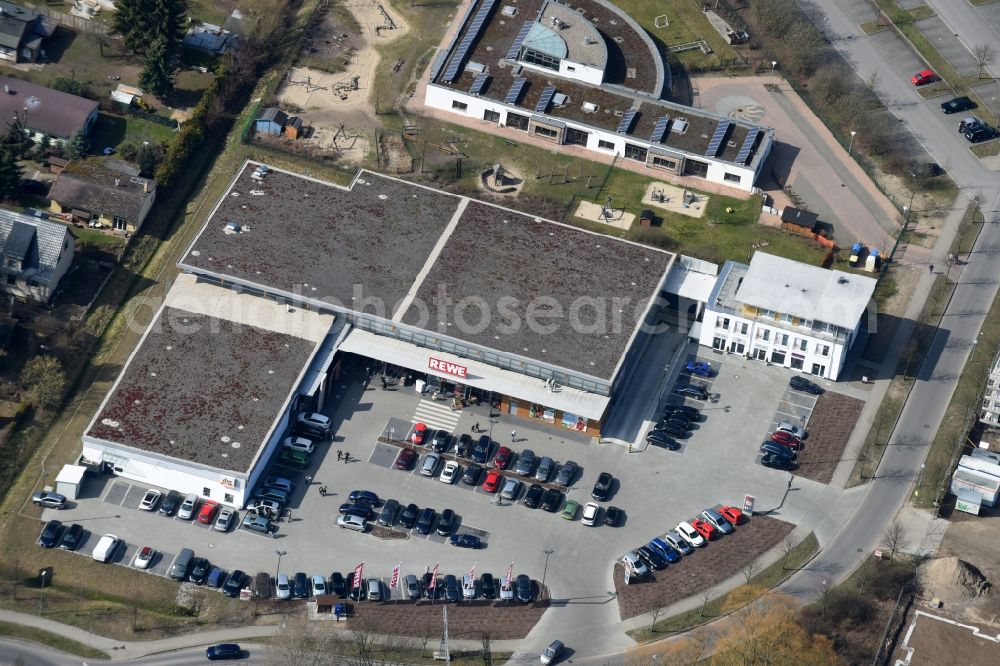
[0, 209, 74, 303]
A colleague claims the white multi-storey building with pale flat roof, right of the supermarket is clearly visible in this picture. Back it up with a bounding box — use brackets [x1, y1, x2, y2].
[699, 252, 876, 380]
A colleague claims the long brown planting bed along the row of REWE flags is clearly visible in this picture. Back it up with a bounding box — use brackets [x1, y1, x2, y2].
[347, 601, 549, 643]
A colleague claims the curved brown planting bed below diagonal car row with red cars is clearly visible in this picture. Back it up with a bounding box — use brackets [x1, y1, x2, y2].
[608, 516, 795, 620]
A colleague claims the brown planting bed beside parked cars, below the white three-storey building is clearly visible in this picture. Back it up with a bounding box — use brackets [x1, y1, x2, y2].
[795, 391, 865, 483]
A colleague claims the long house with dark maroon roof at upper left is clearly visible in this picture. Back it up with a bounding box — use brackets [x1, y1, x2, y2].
[0, 75, 97, 144]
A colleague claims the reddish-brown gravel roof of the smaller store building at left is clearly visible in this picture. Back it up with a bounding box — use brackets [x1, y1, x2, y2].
[87, 307, 316, 472]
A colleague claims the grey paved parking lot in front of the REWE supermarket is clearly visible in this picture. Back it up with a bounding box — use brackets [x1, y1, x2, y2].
[46, 347, 860, 624]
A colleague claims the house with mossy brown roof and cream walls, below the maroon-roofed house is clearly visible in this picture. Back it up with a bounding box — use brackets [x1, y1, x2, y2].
[49, 162, 156, 234]
